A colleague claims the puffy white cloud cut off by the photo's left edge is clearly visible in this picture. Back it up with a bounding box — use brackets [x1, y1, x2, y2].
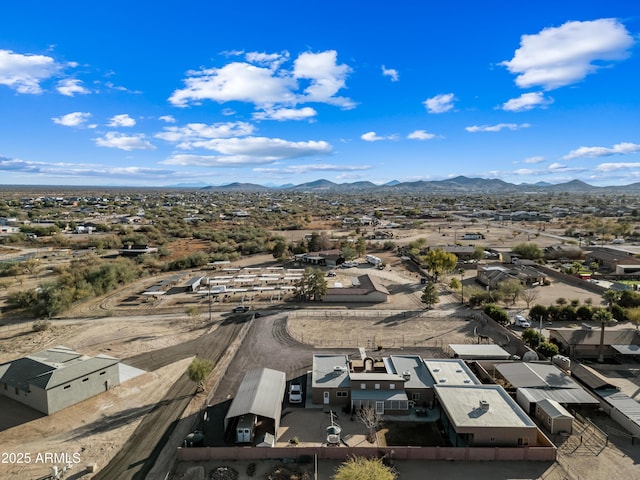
[0, 50, 62, 94]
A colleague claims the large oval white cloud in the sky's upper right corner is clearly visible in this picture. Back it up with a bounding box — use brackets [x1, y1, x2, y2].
[500, 18, 634, 90]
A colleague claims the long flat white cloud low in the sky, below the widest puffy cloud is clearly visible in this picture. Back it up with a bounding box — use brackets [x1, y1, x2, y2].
[162, 137, 332, 166]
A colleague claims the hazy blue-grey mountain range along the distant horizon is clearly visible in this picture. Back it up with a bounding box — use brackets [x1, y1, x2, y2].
[196, 176, 640, 194]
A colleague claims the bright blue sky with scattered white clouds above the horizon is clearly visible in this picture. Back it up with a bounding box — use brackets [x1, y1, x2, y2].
[0, 0, 640, 186]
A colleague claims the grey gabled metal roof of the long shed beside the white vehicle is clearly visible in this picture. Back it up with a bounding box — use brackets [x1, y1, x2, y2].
[225, 368, 287, 425]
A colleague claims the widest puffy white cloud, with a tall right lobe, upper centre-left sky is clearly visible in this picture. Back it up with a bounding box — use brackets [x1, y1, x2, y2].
[169, 50, 354, 109]
